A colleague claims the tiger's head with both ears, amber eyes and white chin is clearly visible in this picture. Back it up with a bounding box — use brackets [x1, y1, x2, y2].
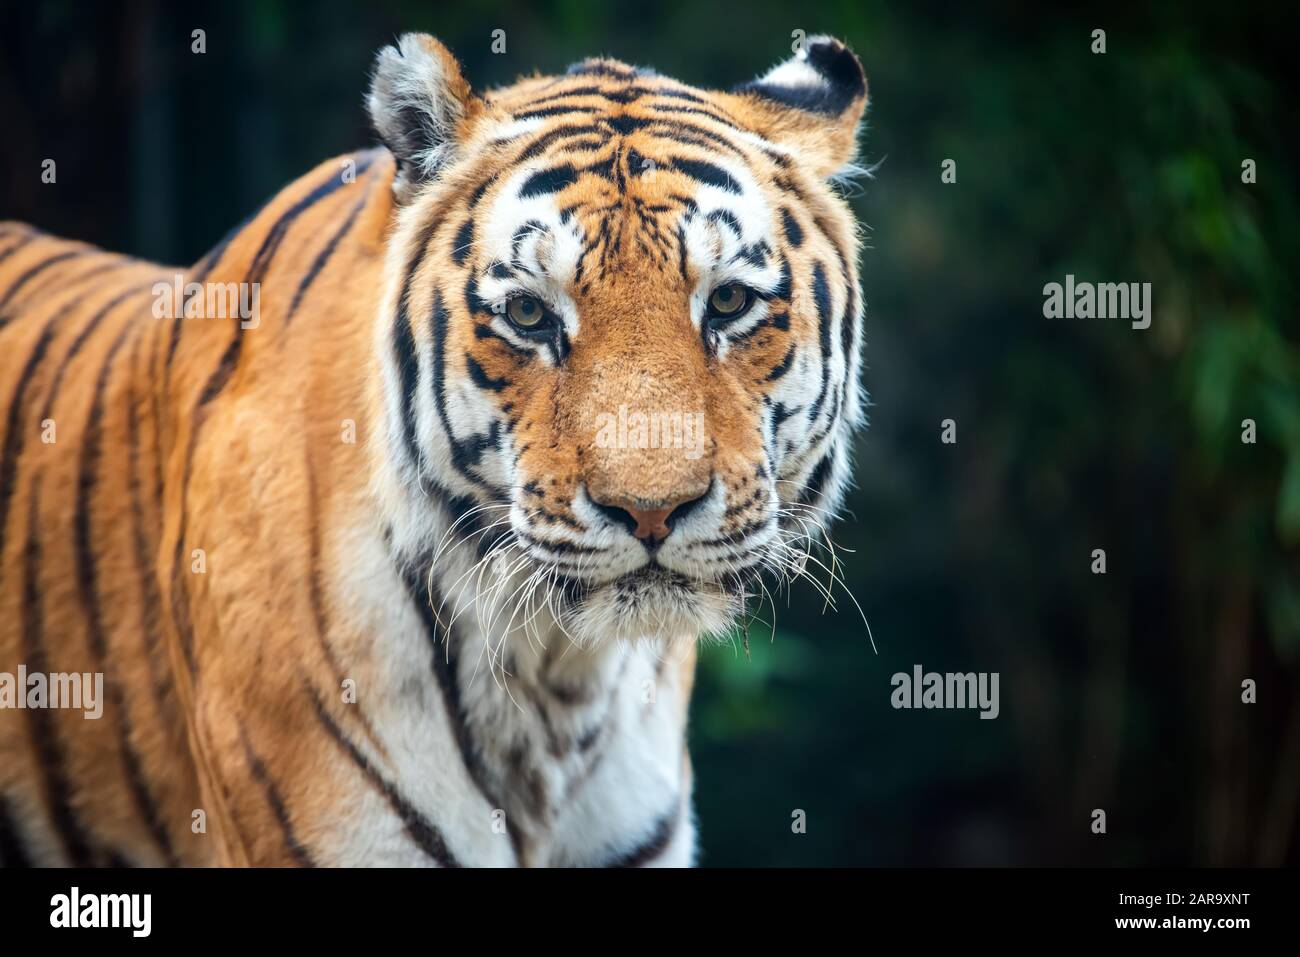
[368, 34, 867, 642]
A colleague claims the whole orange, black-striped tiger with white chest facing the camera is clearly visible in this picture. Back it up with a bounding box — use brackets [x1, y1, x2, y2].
[0, 34, 867, 867]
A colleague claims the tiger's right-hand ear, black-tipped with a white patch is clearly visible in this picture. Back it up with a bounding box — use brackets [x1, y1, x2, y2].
[732, 36, 867, 178]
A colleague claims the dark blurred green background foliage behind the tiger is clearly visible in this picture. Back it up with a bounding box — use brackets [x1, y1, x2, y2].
[0, 0, 1300, 866]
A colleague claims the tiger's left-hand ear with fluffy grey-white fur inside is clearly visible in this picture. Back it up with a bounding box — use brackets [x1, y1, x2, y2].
[365, 34, 484, 203]
